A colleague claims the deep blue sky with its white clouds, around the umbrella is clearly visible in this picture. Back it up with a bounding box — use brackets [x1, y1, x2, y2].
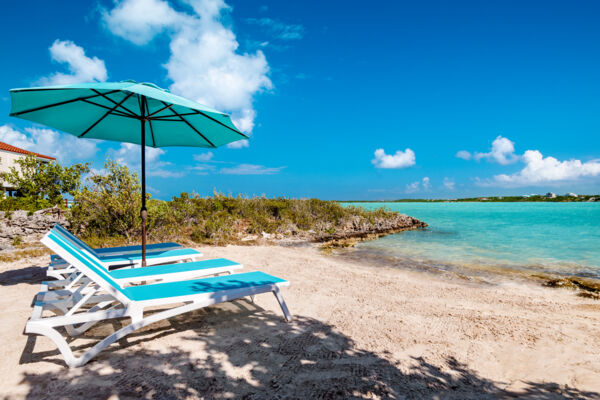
[0, 0, 600, 199]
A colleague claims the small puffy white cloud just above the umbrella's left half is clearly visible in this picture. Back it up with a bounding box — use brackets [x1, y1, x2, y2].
[40, 39, 108, 85]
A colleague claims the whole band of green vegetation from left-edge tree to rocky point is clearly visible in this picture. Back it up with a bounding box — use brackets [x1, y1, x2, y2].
[0, 157, 423, 247]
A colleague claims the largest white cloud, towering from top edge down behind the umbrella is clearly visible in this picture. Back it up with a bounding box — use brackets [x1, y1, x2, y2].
[104, 0, 273, 144]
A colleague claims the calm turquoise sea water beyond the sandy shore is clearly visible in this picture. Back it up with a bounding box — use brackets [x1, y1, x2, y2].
[346, 203, 600, 279]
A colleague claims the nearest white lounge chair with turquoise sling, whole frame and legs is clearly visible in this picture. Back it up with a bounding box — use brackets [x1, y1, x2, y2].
[25, 231, 292, 367]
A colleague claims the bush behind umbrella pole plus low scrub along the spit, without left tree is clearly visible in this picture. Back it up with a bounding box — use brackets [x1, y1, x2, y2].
[61, 161, 412, 245]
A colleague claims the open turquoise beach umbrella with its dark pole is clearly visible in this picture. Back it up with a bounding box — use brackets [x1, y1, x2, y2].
[10, 81, 247, 266]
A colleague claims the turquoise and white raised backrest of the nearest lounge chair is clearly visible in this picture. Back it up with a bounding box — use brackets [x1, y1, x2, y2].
[41, 231, 129, 304]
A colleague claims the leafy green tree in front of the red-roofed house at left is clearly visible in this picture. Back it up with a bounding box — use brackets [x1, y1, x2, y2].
[2, 154, 90, 205]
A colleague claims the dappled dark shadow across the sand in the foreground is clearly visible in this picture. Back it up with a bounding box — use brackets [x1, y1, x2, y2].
[21, 300, 600, 400]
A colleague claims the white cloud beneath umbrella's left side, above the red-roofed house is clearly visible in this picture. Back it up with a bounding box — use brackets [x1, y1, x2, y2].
[0, 125, 98, 164]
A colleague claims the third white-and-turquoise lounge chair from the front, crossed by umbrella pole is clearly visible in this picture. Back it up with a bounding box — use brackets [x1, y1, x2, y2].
[46, 224, 202, 279]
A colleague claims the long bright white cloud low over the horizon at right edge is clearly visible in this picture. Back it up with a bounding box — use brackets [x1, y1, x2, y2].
[490, 150, 600, 187]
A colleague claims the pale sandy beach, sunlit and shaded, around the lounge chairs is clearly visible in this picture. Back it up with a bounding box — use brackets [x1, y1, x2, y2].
[0, 246, 600, 399]
